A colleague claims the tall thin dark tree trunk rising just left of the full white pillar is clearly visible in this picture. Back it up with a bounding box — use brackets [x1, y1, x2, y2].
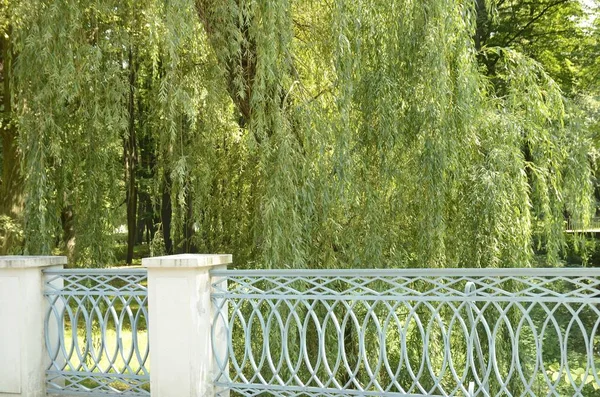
[124, 48, 138, 265]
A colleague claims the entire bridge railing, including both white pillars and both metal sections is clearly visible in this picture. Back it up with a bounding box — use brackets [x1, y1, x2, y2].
[0, 255, 600, 396]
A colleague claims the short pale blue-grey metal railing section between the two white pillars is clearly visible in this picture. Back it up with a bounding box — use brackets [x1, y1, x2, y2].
[44, 268, 150, 396]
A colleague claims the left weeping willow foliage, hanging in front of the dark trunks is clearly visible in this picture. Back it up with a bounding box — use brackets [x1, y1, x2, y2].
[8, 0, 237, 265]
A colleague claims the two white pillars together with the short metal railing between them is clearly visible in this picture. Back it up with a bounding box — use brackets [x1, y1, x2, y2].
[0, 254, 231, 397]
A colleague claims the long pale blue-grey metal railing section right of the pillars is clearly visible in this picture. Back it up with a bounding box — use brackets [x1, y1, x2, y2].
[211, 269, 600, 396]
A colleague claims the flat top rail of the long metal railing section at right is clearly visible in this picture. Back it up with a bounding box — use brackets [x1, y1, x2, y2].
[210, 268, 600, 278]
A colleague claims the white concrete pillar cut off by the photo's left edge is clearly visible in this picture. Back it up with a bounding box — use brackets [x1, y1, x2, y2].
[0, 256, 67, 397]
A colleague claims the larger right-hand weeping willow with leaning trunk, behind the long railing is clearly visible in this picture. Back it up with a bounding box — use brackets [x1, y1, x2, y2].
[198, 0, 592, 267]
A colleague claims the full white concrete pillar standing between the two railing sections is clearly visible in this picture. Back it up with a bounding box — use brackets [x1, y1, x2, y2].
[142, 254, 231, 397]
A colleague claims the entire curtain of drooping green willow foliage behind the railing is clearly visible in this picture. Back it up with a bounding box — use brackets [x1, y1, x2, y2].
[2, 0, 593, 268]
